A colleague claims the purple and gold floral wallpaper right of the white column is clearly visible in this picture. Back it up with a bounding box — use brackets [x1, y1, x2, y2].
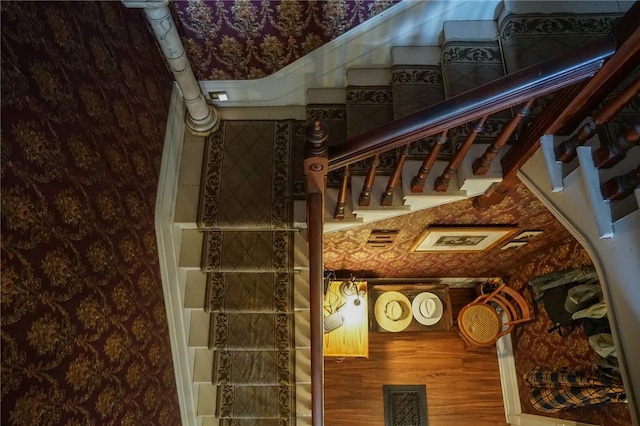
[172, 0, 399, 80]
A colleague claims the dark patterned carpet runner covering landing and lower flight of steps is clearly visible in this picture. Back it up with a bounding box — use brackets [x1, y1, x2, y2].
[198, 121, 301, 426]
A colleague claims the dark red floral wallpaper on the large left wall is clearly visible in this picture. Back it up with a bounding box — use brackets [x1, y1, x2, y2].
[0, 2, 180, 426]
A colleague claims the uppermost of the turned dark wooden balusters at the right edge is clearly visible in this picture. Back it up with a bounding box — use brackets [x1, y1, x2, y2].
[555, 78, 640, 163]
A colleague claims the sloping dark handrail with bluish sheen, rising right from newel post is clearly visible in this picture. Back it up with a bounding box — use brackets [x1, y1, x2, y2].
[329, 35, 616, 170]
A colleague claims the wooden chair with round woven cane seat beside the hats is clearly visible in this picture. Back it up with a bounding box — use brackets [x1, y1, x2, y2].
[458, 284, 531, 348]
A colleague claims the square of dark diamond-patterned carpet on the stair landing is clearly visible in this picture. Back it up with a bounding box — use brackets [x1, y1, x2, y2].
[198, 120, 293, 230]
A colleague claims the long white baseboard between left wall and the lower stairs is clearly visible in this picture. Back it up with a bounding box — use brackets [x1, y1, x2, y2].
[155, 83, 197, 425]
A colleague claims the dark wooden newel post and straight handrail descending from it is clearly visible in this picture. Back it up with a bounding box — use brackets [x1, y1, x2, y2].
[304, 121, 329, 426]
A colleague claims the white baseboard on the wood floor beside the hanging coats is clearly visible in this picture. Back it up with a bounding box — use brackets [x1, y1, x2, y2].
[496, 334, 594, 426]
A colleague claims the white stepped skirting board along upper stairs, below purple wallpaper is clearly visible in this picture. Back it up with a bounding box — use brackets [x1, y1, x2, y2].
[200, 0, 502, 107]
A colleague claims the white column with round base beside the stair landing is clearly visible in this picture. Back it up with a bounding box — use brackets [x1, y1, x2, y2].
[122, 0, 220, 136]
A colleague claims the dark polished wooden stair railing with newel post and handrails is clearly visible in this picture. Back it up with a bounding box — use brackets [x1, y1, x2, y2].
[304, 2, 640, 426]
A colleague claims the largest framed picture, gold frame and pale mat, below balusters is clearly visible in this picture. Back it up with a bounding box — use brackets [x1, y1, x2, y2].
[409, 226, 518, 253]
